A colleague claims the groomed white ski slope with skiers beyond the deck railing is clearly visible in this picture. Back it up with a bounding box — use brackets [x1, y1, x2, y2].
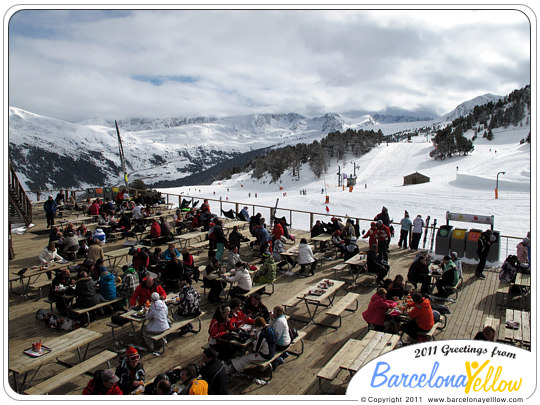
[157, 126, 535, 260]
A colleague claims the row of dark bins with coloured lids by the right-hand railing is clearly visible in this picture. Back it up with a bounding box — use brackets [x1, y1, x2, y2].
[435, 225, 500, 262]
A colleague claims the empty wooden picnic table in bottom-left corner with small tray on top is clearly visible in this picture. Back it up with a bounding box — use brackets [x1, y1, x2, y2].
[9, 328, 102, 393]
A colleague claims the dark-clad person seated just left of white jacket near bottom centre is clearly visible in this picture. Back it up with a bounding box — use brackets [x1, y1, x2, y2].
[229, 317, 276, 374]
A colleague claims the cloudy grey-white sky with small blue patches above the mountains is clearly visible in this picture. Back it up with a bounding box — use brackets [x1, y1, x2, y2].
[8, 5, 531, 122]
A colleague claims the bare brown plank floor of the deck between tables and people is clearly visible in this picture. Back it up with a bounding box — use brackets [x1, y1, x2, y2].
[5, 208, 528, 395]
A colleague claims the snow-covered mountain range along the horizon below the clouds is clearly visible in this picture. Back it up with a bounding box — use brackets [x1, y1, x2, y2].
[9, 95, 506, 190]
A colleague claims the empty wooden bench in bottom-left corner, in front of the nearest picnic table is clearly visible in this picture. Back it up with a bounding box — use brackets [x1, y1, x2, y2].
[24, 350, 116, 395]
